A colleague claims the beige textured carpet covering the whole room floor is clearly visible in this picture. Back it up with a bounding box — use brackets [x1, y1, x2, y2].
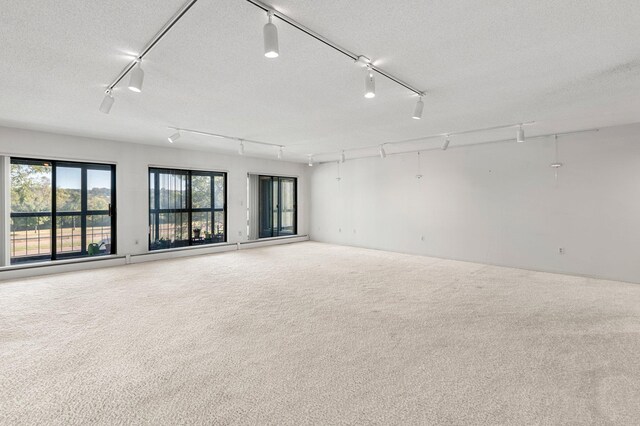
[0, 242, 640, 425]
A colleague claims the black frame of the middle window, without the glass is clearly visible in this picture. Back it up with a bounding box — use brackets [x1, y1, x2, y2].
[147, 167, 229, 251]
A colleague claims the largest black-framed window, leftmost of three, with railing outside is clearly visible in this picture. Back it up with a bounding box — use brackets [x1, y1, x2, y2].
[10, 158, 116, 264]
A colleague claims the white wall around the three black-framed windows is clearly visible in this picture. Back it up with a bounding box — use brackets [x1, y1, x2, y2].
[0, 127, 309, 262]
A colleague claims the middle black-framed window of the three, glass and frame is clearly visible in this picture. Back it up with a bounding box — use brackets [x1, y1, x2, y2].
[149, 168, 227, 250]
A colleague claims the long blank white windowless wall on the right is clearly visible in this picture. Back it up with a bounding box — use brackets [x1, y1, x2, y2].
[311, 125, 640, 282]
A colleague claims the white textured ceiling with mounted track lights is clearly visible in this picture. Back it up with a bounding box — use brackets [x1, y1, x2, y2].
[0, 0, 640, 161]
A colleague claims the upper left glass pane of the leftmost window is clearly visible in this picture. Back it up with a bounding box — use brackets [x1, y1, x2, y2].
[11, 163, 52, 213]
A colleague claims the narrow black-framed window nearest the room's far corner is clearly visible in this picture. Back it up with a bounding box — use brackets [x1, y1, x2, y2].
[258, 176, 297, 238]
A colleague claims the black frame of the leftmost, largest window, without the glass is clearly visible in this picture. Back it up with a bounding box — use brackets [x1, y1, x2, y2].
[9, 157, 118, 265]
